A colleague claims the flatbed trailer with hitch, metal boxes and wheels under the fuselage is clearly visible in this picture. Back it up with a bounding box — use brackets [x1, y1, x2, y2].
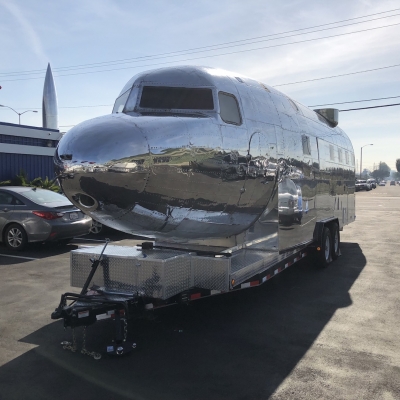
[51, 220, 340, 359]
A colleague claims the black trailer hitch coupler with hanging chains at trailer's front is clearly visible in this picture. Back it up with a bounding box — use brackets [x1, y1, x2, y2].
[51, 287, 143, 360]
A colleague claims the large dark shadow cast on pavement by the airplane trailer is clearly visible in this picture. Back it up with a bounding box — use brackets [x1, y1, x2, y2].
[0, 243, 366, 400]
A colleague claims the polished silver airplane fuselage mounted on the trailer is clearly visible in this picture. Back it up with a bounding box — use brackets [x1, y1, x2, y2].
[55, 66, 355, 251]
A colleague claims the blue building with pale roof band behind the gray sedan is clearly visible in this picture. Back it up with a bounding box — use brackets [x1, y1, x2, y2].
[0, 122, 62, 181]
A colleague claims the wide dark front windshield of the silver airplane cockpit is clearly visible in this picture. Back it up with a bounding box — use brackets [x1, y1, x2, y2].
[139, 86, 214, 110]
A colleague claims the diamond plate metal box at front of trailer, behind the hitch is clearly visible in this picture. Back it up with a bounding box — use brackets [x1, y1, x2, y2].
[71, 245, 192, 300]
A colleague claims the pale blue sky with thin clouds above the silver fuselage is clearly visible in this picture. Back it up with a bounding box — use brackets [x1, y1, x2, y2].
[0, 0, 400, 169]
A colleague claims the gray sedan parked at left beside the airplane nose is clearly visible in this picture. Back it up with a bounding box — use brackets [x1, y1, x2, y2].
[0, 186, 92, 250]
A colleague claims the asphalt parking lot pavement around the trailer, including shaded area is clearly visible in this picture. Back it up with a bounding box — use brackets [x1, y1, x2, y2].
[0, 185, 400, 400]
